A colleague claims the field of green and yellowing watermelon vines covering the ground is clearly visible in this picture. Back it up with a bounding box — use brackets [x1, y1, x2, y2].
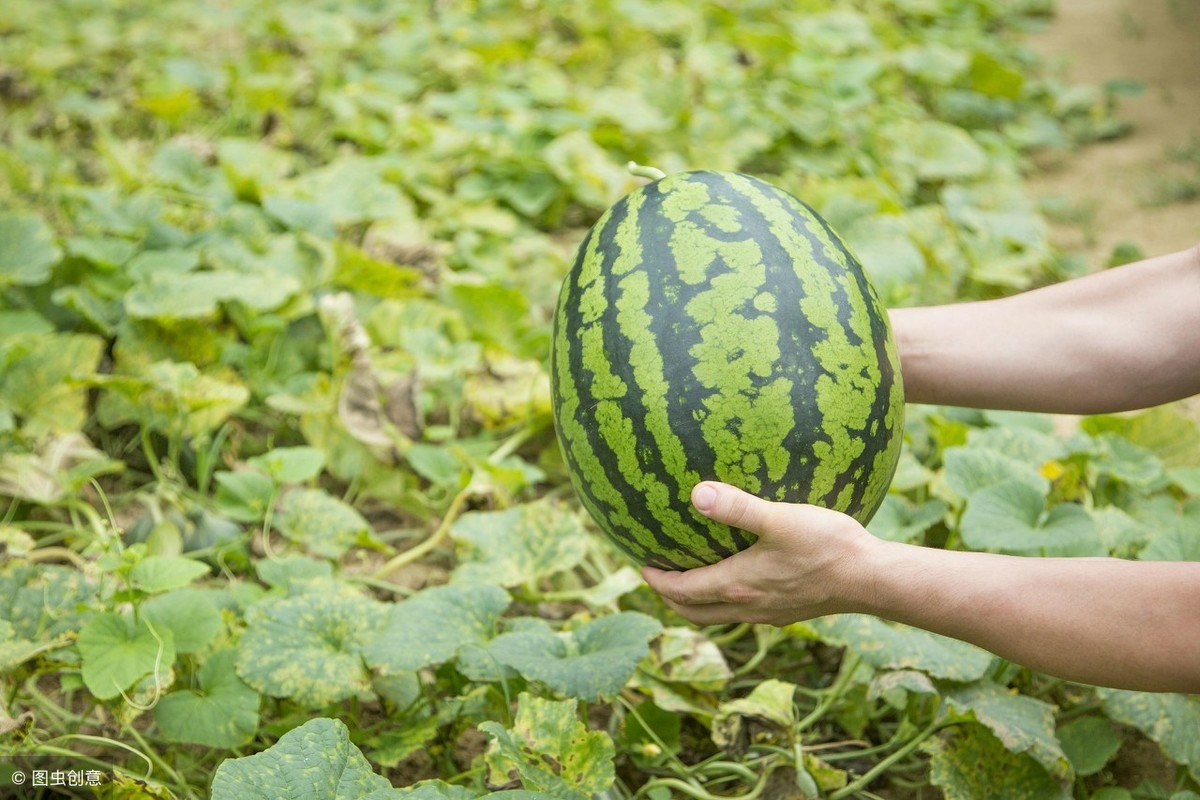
[0, 0, 1200, 800]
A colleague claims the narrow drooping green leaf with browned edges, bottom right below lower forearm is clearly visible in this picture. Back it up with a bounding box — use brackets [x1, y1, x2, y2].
[942, 681, 1070, 778]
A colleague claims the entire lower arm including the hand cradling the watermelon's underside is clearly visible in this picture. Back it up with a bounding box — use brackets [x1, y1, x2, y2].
[644, 482, 1200, 692]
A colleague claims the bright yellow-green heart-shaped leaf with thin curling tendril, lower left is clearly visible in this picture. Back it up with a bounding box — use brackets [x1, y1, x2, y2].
[76, 612, 175, 700]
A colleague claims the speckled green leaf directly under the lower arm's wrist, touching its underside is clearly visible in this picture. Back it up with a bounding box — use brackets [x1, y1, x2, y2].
[809, 614, 995, 681]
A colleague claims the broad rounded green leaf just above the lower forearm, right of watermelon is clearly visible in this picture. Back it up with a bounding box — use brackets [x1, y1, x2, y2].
[961, 480, 1105, 555]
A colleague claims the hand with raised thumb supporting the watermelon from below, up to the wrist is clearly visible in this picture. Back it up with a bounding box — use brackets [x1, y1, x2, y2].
[642, 481, 884, 625]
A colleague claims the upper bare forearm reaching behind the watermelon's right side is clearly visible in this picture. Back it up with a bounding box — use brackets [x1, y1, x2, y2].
[890, 248, 1200, 414]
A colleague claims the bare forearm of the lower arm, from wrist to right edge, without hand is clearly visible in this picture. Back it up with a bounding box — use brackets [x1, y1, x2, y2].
[863, 542, 1200, 692]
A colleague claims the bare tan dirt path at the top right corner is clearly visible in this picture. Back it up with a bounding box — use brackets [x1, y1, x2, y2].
[1031, 0, 1200, 261]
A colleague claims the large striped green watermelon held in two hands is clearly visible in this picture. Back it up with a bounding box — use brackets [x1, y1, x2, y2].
[552, 172, 904, 569]
